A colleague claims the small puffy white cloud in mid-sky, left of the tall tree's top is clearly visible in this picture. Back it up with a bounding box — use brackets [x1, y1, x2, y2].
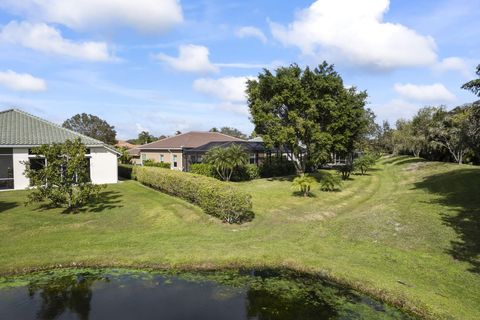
[156, 44, 219, 73]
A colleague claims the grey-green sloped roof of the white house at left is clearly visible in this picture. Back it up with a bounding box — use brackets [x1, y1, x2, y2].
[0, 109, 108, 148]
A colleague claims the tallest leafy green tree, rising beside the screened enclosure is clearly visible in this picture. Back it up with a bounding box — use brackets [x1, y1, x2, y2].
[247, 62, 367, 172]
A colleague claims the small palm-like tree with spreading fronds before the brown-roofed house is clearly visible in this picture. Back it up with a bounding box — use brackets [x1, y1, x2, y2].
[205, 144, 248, 181]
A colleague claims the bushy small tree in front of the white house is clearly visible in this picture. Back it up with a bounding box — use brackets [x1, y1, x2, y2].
[25, 139, 101, 210]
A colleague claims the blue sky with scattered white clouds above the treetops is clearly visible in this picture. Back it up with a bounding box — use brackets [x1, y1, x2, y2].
[0, 0, 480, 139]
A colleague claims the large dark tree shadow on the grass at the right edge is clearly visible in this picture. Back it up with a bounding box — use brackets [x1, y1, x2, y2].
[415, 169, 480, 274]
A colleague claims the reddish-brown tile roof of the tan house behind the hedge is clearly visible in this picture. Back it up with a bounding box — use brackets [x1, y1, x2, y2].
[137, 131, 245, 150]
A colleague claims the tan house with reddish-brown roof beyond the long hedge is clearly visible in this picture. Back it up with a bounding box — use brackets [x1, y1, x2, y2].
[128, 131, 265, 171]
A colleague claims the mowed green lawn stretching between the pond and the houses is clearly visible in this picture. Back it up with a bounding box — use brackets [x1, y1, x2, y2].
[0, 157, 480, 319]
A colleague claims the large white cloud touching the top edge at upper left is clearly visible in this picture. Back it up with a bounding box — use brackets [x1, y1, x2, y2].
[0, 0, 183, 32]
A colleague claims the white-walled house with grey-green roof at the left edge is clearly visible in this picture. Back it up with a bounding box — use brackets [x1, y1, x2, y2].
[0, 109, 119, 189]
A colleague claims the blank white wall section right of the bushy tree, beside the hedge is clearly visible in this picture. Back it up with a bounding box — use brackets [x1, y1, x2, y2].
[90, 148, 118, 184]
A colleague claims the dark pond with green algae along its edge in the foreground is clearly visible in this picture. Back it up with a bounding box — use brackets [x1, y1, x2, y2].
[0, 269, 411, 320]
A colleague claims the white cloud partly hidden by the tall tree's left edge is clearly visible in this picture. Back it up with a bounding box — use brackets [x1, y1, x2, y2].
[193, 77, 254, 102]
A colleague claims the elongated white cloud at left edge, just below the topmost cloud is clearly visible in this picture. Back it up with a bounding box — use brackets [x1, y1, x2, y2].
[0, 21, 114, 61]
